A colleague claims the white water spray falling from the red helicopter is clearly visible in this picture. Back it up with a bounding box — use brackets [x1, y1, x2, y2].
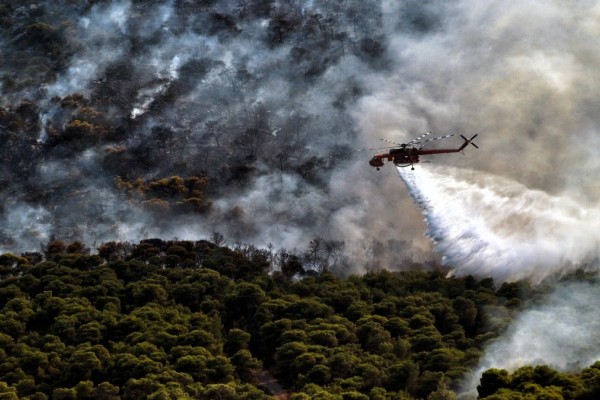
[398, 167, 600, 283]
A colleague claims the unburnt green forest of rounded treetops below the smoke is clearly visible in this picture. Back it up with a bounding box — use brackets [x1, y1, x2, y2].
[0, 239, 600, 400]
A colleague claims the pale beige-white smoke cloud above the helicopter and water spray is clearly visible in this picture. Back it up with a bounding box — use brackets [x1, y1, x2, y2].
[356, 0, 600, 202]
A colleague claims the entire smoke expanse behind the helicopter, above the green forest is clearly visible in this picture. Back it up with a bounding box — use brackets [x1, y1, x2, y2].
[0, 0, 600, 279]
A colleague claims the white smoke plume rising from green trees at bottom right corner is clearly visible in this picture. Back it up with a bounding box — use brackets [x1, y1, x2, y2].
[463, 282, 600, 398]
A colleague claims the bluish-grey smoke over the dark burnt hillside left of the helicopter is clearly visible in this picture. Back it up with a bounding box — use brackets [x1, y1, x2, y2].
[0, 0, 430, 271]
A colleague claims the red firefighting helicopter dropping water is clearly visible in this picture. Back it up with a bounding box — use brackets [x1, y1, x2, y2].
[366, 132, 479, 171]
